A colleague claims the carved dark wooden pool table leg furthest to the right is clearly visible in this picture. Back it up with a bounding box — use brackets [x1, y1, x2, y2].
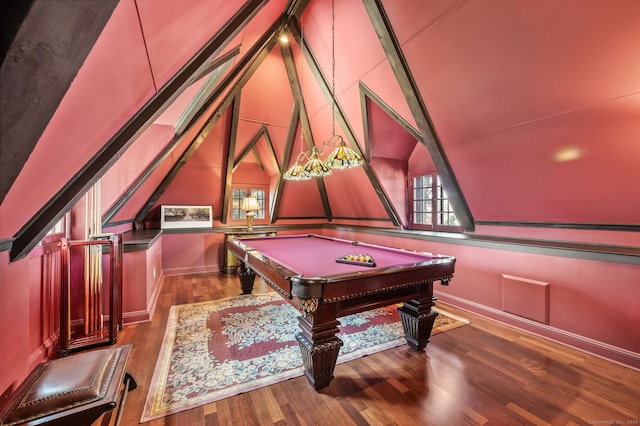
[398, 282, 438, 351]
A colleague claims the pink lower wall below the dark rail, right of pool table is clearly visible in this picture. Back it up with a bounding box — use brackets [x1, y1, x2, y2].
[325, 230, 640, 368]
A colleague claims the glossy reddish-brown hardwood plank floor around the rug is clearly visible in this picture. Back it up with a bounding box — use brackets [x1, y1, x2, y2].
[118, 274, 640, 426]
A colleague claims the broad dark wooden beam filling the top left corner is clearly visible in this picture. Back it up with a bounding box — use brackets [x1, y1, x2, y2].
[0, 0, 118, 203]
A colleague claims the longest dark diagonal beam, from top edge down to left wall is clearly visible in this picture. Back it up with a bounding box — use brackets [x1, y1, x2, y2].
[10, 0, 268, 261]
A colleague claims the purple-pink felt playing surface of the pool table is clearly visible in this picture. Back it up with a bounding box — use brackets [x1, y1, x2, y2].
[242, 235, 438, 278]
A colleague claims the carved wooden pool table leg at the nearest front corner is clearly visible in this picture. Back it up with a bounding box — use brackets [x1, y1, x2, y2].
[296, 306, 342, 390]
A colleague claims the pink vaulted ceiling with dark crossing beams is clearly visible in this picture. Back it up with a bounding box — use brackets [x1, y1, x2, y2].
[0, 0, 640, 259]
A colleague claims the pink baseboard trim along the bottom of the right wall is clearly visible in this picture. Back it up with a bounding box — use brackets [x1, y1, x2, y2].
[434, 291, 640, 371]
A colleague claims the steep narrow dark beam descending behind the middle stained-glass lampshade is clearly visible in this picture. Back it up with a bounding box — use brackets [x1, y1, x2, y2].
[280, 36, 333, 222]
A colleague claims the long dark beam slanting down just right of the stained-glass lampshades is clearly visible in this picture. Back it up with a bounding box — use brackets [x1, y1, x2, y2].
[290, 17, 401, 226]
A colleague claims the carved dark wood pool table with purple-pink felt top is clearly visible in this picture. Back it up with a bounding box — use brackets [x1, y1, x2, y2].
[227, 234, 455, 390]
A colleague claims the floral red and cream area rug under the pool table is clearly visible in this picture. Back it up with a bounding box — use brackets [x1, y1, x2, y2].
[140, 293, 468, 423]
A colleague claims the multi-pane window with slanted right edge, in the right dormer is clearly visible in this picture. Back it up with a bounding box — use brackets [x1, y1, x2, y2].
[410, 173, 460, 231]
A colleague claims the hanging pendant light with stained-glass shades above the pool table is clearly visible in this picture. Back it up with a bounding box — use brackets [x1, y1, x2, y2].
[283, 0, 364, 180]
